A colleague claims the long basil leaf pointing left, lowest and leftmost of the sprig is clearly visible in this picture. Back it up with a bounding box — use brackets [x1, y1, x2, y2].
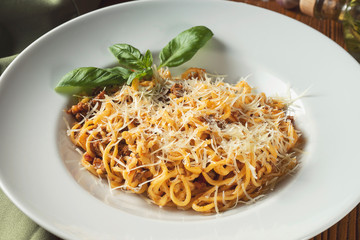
[55, 67, 130, 94]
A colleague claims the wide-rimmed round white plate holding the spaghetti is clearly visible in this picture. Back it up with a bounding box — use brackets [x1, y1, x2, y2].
[0, 0, 360, 239]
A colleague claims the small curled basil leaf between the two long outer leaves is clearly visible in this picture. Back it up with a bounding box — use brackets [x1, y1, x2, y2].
[109, 44, 145, 70]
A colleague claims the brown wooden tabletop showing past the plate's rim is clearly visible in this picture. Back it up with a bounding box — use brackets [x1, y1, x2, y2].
[100, 0, 360, 240]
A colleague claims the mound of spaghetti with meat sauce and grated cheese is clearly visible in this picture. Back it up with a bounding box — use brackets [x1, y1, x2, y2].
[68, 68, 300, 212]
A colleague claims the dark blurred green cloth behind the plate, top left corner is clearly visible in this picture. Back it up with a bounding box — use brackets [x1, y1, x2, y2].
[0, 0, 101, 58]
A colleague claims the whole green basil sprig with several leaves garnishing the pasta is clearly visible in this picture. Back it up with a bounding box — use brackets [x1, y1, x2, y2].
[55, 26, 213, 94]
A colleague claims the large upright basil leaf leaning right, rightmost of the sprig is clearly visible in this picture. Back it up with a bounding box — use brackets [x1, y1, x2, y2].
[159, 26, 214, 67]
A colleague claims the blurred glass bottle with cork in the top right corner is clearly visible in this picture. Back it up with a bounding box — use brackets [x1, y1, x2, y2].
[300, 0, 360, 62]
